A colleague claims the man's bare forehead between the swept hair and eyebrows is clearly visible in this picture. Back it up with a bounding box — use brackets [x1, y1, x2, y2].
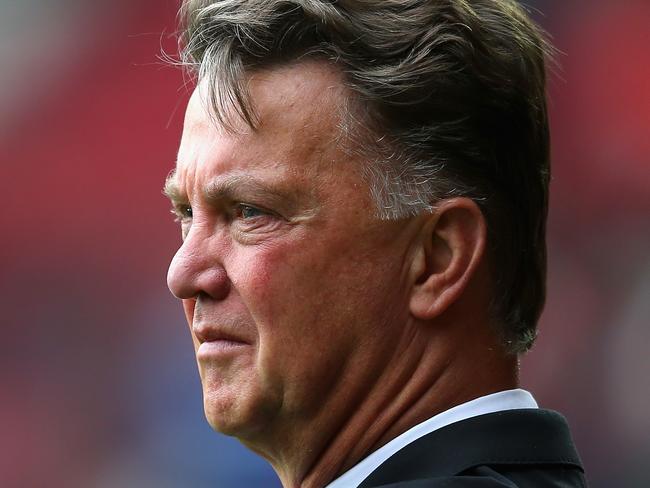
[177, 61, 345, 185]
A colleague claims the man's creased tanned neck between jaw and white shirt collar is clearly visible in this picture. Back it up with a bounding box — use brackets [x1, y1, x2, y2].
[249, 318, 518, 488]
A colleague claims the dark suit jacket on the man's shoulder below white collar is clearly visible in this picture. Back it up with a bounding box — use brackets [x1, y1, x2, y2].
[359, 409, 587, 488]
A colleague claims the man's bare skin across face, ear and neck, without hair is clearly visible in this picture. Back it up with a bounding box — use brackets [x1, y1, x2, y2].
[165, 61, 517, 487]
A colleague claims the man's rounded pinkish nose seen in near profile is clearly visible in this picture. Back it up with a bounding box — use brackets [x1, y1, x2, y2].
[167, 226, 230, 300]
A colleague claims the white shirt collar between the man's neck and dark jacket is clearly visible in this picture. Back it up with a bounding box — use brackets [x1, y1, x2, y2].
[326, 389, 537, 488]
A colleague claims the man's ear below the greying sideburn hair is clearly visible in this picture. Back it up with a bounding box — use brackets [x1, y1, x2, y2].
[409, 198, 487, 320]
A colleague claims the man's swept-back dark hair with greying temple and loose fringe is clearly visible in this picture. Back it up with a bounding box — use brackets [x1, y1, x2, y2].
[180, 0, 550, 354]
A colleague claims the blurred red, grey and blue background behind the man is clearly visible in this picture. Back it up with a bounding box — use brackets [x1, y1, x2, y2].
[0, 0, 650, 488]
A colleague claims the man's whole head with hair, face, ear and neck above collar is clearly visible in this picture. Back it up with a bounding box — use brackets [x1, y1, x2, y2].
[166, 0, 548, 481]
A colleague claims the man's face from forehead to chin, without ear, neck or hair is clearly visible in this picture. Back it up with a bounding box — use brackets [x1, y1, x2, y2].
[167, 62, 412, 438]
